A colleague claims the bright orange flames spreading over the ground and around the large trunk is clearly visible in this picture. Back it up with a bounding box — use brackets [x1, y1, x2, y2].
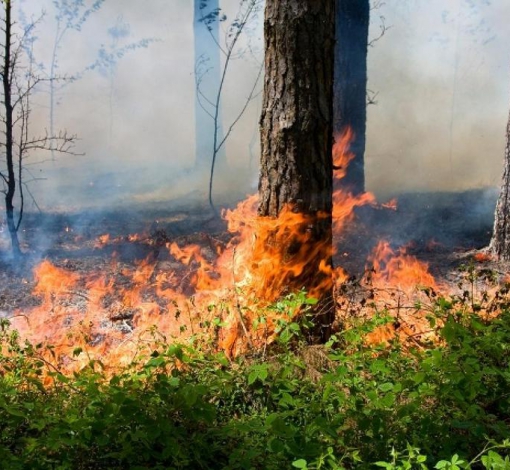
[3, 127, 435, 370]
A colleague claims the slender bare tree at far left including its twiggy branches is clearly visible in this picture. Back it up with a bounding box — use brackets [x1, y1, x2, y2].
[0, 0, 74, 256]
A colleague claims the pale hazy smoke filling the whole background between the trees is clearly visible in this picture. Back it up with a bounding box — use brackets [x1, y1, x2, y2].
[7, 0, 510, 210]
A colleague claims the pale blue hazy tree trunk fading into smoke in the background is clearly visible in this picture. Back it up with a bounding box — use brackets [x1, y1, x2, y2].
[193, 0, 225, 169]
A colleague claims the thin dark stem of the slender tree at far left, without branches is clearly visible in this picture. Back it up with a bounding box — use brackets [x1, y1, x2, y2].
[2, 0, 21, 256]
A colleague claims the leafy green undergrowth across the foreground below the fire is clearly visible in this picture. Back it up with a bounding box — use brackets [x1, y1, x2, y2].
[0, 293, 510, 470]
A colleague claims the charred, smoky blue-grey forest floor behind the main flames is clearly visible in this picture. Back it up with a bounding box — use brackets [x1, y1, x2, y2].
[0, 190, 505, 315]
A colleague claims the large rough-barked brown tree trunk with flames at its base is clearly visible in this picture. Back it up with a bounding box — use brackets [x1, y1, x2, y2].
[258, 0, 335, 340]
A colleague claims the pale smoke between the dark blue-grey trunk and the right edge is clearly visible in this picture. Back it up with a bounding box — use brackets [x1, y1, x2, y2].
[367, 0, 510, 195]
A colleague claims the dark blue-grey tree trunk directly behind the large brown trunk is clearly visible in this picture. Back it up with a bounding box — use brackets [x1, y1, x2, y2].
[333, 0, 370, 194]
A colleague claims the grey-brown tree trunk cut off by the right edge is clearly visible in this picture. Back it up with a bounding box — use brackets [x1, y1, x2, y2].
[489, 107, 510, 261]
